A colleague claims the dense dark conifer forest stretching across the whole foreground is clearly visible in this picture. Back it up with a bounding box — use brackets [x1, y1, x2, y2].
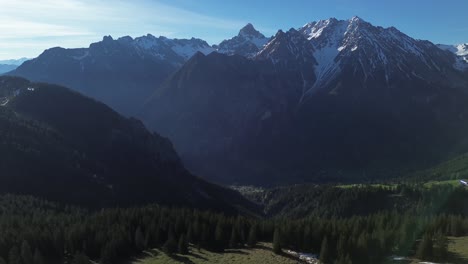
[0, 185, 468, 264]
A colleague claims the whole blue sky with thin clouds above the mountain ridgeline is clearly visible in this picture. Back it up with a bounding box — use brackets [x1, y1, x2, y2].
[0, 0, 468, 60]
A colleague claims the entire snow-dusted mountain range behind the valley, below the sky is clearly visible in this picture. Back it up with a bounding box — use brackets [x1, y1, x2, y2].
[10, 17, 468, 185]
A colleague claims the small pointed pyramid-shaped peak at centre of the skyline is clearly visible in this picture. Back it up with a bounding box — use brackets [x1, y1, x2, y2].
[214, 23, 269, 57]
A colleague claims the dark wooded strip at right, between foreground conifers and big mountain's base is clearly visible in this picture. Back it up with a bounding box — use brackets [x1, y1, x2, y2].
[246, 184, 468, 218]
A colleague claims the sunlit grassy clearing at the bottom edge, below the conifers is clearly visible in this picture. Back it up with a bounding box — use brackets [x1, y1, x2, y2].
[130, 243, 298, 264]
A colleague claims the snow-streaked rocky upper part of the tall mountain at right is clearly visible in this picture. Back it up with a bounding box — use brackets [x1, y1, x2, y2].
[299, 17, 462, 93]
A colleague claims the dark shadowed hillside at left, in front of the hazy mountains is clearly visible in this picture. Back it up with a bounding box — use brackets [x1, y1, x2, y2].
[0, 77, 256, 212]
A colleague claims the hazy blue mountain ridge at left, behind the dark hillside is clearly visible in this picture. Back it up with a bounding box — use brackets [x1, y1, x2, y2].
[9, 35, 213, 115]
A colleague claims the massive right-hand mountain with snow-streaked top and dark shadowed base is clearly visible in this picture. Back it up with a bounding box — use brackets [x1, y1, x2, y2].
[142, 17, 468, 184]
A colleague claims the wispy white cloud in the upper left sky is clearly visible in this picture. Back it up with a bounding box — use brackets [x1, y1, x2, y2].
[0, 0, 244, 59]
